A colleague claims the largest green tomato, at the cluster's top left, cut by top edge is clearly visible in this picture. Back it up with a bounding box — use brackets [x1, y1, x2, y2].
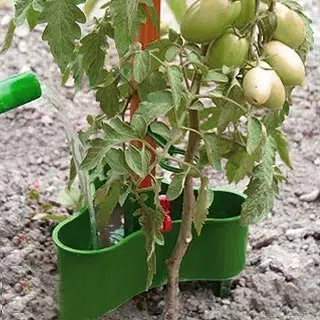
[181, 0, 241, 43]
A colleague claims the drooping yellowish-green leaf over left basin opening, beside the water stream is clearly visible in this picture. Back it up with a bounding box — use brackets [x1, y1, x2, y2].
[96, 181, 122, 230]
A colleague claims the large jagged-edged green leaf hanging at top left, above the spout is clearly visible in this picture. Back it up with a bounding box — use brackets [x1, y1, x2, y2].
[40, 0, 86, 72]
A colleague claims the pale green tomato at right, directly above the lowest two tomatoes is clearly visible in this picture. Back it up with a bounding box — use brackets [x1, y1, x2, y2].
[264, 40, 306, 86]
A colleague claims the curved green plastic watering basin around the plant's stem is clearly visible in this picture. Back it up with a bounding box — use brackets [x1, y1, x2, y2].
[53, 189, 248, 320]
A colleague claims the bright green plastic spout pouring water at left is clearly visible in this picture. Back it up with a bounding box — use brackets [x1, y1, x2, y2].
[0, 72, 42, 114]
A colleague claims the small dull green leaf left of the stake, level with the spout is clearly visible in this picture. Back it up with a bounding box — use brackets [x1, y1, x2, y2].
[96, 83, 120, 118]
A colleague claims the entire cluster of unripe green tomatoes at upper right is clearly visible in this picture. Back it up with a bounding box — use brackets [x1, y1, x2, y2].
[181, 0, 306, 109]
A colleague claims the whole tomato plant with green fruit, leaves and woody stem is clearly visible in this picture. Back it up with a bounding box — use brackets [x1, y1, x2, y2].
[3, 0, 313, 320]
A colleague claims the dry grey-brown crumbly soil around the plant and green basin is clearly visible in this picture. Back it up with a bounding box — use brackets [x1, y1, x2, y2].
[0, 0, 320, 320]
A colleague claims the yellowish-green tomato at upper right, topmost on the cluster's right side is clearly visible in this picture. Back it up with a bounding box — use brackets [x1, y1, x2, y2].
[273, 3, 306, 49]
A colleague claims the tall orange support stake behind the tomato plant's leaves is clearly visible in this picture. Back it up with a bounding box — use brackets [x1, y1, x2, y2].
[130, 0, 161, 188]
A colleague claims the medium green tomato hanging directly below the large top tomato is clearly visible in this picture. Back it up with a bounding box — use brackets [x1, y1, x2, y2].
[206, 32, 250, 69]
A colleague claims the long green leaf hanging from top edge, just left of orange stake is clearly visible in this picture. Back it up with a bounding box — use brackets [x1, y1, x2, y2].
[110, 0, 139, 57]
